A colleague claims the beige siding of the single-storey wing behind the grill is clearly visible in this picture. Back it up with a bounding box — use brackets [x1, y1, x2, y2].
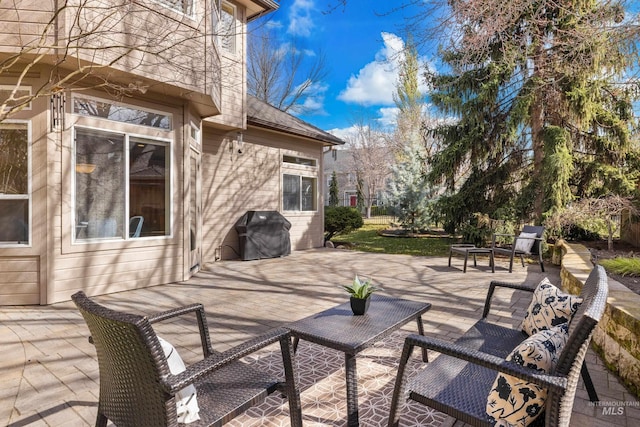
[202, 128, 324, 263]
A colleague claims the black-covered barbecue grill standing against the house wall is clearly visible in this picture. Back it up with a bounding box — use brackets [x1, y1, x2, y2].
[235, 211, 291, 261]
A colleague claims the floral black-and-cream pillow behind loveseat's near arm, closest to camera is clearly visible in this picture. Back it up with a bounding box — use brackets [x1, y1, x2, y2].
[487, 323, 569, 427]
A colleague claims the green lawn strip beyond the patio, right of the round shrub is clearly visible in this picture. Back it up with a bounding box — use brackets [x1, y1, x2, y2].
[332, 224, 454, 256]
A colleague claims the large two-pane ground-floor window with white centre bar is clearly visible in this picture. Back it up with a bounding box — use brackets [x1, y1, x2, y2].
[74, 127, 170, 241]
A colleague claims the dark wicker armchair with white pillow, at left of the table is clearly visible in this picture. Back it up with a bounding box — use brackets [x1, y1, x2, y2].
[72, 292, 302, 427]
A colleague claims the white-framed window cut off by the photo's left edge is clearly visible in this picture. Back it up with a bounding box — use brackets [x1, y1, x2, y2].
[0, 123, 31, 245]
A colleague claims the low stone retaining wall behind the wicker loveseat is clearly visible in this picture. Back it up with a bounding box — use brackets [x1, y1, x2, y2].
[560, 244, 640, 397]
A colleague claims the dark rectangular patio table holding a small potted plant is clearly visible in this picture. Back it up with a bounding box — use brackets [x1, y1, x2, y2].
[285, 294, 431, 426]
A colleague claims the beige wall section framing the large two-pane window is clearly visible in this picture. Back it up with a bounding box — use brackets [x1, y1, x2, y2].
[47, 93, 185, 303]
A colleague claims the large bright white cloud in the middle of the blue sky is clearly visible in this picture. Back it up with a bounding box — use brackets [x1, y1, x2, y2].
[338, 33, 404, 106]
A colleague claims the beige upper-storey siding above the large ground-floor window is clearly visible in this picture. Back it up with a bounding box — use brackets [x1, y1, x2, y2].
[0, 0, 221, 114]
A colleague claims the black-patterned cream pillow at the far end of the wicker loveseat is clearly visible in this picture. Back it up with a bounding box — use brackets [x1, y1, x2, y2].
[522, 277, 582, 335]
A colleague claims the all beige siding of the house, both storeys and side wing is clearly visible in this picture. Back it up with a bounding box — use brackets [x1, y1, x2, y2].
[0, 0, 331, 305]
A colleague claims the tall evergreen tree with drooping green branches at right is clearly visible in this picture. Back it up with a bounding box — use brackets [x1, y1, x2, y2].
[422, 0, 637, 229]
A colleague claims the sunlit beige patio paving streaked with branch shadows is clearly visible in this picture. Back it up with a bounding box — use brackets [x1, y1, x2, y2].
[0, 249, 640, 427]
